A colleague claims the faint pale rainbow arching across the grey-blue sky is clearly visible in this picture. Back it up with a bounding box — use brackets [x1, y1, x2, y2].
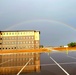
[5, 19, 76, 31]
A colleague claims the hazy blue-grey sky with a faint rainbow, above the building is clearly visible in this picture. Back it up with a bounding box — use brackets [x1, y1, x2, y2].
[0, 0, 76, 46]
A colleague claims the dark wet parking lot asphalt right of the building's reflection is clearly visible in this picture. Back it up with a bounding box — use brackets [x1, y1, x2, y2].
[24, 51, 76, 75]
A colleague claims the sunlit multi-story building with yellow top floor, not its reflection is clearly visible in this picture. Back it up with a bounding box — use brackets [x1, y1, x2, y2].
[0, 30, 40, 50]
